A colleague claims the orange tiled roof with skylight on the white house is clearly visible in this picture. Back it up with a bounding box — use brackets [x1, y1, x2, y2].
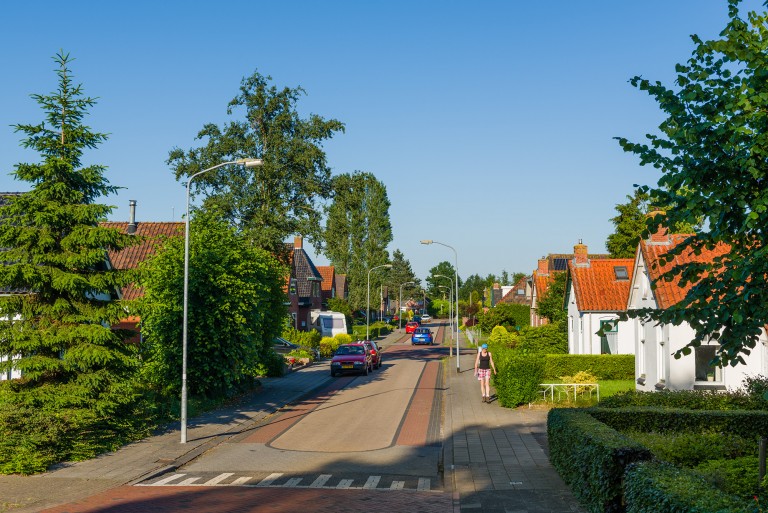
[568, 258, 635, 312]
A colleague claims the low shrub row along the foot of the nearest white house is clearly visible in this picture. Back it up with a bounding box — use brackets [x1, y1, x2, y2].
[600, 390, 765, 410]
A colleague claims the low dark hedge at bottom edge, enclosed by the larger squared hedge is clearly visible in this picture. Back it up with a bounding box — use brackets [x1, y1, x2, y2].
[624, 461, 757, 513]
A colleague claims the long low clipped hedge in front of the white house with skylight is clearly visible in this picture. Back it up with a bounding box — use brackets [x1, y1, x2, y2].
[544, 354, 635, 379]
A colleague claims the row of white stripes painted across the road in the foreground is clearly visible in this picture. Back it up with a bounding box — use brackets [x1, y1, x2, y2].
[136, 472, 437, 492]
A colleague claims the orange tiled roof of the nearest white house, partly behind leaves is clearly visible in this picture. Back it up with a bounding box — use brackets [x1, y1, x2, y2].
[640, 234, 731, 309]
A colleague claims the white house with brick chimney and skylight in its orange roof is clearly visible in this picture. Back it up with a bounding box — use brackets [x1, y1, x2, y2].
[565, 241, 637, 354]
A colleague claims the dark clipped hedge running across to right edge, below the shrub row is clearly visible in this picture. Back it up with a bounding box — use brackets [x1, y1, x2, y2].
[589, 407, 768, 438]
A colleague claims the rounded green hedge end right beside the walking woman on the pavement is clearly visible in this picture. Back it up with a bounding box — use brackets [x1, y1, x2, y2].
[493, 350, 545, 408]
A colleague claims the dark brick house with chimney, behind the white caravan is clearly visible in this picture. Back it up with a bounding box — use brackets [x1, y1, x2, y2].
[286, 236, 323, 331]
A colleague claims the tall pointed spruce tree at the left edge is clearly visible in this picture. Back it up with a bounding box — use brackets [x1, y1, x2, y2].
[0, 52, 138, 412]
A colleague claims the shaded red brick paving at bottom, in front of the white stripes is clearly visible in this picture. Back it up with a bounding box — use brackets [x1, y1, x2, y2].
[43, 486, 453, 513]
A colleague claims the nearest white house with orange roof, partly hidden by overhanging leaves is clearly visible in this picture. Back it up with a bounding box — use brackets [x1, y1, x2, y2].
[627, 221, 768, 391]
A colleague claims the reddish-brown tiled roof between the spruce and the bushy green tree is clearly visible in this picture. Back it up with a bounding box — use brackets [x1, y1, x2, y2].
[99, 222, 184, 300]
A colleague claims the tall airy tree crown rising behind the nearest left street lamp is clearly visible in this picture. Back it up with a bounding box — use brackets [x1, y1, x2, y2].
[168, 71, 344, 254]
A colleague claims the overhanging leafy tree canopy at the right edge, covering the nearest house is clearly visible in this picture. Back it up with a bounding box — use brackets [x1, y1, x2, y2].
[618, 0, 768, 365]
